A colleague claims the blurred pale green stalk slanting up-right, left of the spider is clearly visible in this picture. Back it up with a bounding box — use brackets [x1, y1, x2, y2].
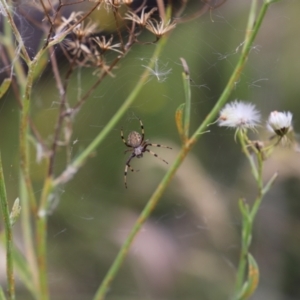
[54, 37, 167, 185]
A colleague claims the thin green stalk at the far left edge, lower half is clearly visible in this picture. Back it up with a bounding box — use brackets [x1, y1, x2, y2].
[0, 154, 15, 300]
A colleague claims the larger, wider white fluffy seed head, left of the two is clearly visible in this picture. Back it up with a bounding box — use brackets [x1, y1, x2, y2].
[218, 100, 260, 129]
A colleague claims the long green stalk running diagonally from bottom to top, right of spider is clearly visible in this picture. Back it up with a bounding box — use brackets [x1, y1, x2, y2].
[94, 0, 274, 300]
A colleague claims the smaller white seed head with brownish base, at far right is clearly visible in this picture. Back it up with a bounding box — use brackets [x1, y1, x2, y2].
[267, 110, 293, 137]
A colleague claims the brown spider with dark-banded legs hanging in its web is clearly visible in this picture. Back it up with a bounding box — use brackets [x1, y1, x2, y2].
[121, 119, 172, 188]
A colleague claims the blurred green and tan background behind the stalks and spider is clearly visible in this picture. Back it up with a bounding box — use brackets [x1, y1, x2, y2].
[0, 0, 300, 300]
